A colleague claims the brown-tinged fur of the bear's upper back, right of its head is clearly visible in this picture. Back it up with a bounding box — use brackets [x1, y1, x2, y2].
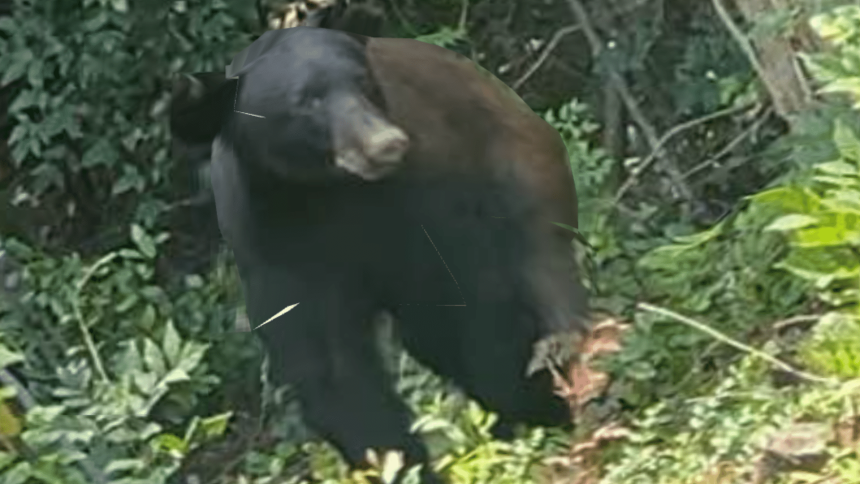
[367, 38, 577, 227]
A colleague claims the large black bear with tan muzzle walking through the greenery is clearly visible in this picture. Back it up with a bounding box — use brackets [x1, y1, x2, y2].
[172, 27, 586, 483]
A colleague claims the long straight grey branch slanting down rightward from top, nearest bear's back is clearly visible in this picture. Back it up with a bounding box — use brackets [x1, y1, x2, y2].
[567, 0, 693, 200]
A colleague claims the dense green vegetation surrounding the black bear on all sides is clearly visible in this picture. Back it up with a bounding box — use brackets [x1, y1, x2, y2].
[0, 0, 860, 484]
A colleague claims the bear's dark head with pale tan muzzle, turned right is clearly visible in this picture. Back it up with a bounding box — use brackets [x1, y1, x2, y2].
[221, 27, 409, 182]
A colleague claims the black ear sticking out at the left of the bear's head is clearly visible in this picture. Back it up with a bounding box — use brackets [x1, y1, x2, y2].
[170, 72, 236, 143]
